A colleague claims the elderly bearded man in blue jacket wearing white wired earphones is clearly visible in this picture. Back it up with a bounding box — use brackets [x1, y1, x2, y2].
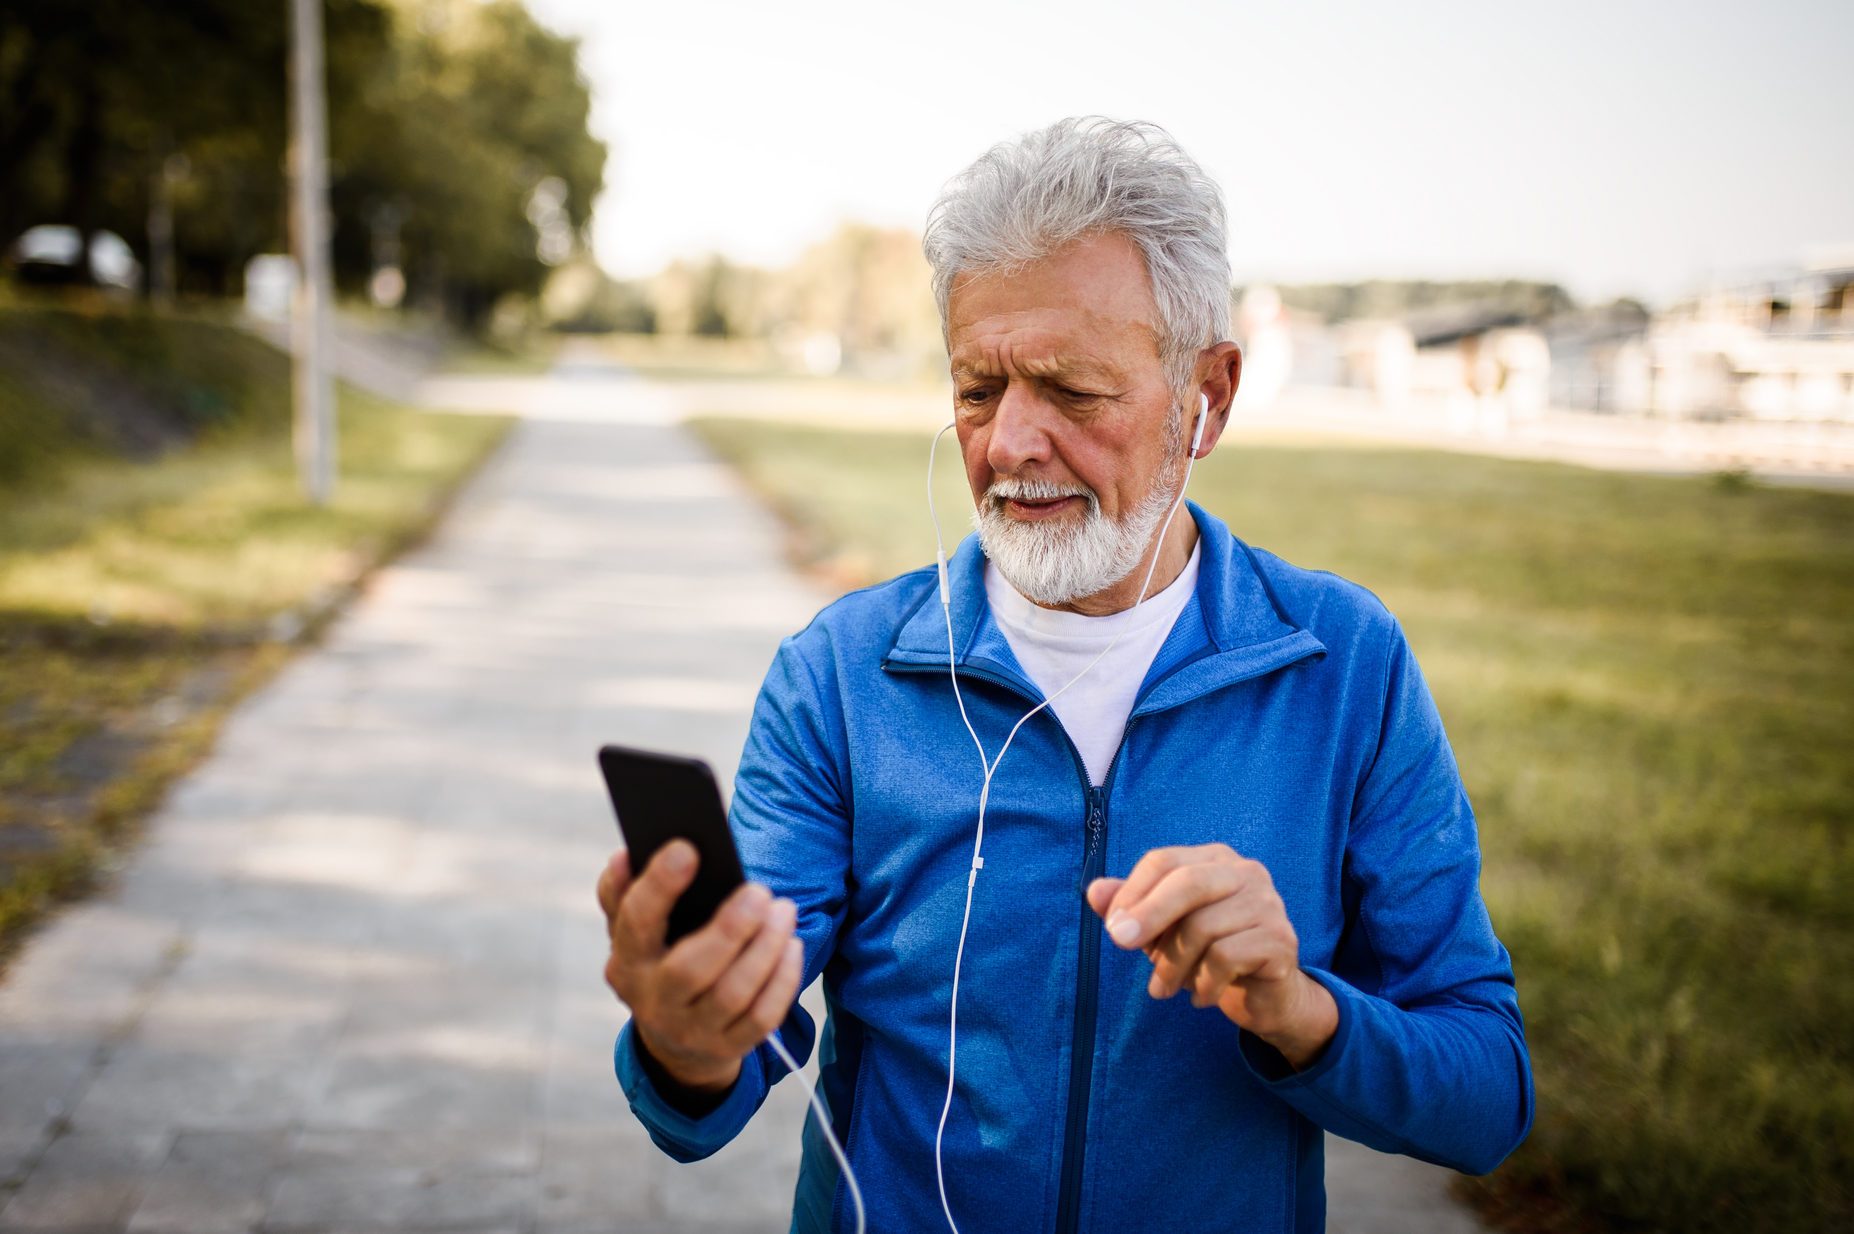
[599, 119, 1531, 1234]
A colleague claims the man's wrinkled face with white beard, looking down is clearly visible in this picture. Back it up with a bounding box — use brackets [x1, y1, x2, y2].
[947, 232, 1185, 604]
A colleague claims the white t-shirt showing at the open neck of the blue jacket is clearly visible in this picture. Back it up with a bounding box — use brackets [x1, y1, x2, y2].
[984, 541, 1201, 784]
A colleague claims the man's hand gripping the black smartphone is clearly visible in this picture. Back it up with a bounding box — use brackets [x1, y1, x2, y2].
[599, 839, 805, 1093]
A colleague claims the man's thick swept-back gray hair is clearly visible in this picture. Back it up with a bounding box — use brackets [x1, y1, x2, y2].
[921, 115, 1229, 389]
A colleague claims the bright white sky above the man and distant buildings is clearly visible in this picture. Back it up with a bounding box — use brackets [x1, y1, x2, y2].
[528, 0, 1854, 302]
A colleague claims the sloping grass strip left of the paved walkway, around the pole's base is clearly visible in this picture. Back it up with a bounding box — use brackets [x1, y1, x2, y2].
[0, 306, 512, 952]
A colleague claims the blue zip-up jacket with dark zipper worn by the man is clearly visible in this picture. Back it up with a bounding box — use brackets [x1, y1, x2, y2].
[616, 502, 1533, 1234]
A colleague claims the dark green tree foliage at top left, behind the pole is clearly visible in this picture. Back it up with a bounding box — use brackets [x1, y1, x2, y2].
[0, 0, 606, 322]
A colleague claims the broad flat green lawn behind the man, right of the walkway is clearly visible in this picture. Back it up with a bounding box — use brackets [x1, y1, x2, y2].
[699, 421, 1854, 1234]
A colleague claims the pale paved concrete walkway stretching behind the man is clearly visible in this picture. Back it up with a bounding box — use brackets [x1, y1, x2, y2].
[0, 370, 1476, 1234]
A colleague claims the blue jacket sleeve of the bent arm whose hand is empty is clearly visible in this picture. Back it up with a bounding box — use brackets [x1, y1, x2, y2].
[1240, 621, 1533, 1173]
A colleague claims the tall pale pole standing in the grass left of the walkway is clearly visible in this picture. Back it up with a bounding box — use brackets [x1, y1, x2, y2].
[289, 0, 336, 506]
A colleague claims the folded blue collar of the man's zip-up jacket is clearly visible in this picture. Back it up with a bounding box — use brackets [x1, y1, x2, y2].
[883, 500, 1326, 715]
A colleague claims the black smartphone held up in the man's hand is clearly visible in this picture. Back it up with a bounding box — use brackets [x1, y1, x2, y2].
[599, 745, 747, 943]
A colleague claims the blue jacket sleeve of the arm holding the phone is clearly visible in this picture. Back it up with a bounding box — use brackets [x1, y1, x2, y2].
[614, 624, 849, 1162]
